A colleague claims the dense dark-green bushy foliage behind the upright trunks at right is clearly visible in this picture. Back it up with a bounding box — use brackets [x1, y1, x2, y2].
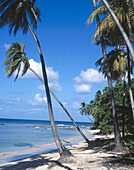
[82, 80, 134, 134]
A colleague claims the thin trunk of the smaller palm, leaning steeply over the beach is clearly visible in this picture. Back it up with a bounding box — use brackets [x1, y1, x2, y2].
[29, 67, 92, 144]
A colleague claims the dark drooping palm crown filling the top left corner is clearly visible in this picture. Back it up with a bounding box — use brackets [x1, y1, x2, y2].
[0, 0, 40, 34]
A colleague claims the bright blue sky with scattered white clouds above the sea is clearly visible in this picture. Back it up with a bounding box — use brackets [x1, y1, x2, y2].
[0, 0, 107, 122]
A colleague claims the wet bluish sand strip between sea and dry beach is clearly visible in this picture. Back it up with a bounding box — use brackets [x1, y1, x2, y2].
[0, 129, 93, 166]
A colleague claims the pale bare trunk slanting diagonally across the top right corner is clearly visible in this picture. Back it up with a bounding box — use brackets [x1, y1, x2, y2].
[102, 0, 134, 63]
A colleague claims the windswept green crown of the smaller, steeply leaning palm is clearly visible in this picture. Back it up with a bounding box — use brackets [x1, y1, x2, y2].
[4, 42, 30, 80]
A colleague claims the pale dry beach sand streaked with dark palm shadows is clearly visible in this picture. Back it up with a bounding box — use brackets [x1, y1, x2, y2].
[0, 130, 134, 170]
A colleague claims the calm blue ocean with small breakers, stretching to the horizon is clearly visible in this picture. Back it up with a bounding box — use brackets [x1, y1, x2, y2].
[0, 119, 92, 153]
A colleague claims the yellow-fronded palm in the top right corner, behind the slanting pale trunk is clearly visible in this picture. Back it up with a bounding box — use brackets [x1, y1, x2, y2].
[88, 0, 134, 120]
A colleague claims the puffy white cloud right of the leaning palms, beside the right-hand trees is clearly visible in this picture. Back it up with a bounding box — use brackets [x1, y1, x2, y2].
[74, 68, 105, 94]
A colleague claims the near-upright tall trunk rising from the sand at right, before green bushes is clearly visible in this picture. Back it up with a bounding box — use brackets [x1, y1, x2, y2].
[92, 0, 122, 150]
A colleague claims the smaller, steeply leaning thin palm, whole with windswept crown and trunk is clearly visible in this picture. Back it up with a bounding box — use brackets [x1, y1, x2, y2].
[4, 42, 90, 144]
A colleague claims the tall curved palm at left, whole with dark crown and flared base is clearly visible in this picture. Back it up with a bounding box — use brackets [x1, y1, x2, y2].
[0, 0, 72, 156]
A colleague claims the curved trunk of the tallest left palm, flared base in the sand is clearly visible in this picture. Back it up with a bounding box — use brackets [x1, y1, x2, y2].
[28, 23, 73, 156]
